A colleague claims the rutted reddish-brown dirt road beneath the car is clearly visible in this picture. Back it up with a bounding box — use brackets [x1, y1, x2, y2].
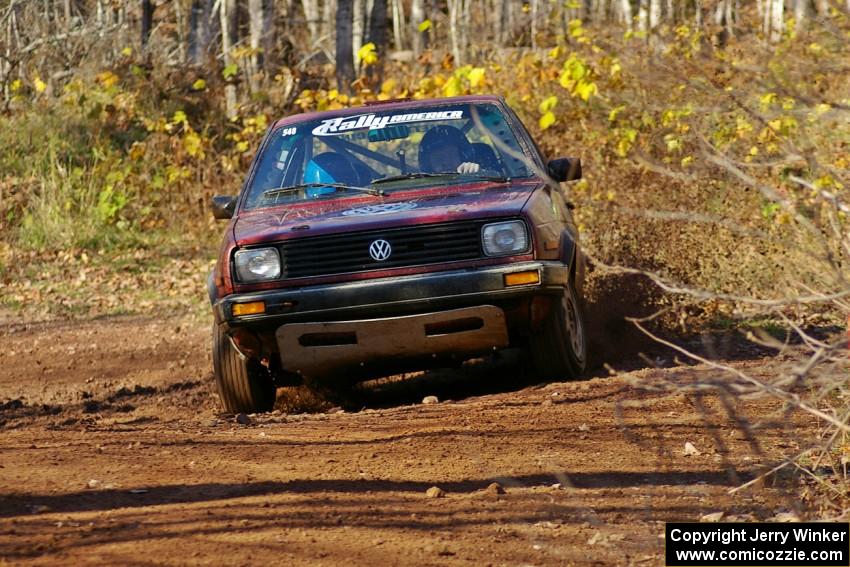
[0, 317, 814, 565]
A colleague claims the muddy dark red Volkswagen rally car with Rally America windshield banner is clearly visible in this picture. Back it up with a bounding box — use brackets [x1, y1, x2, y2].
[208, 96, 587, 413]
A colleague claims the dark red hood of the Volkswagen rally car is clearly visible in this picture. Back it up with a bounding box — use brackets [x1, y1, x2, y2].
[233, 179, 542, 246]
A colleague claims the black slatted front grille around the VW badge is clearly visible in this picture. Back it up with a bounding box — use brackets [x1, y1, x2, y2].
[280, 220, 487, 278]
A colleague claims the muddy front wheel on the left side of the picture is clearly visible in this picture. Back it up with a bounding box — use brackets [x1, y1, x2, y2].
[212, 324, 275, 413]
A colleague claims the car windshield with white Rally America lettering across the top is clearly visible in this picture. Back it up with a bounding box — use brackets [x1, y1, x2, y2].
[245, 103, 531, 209]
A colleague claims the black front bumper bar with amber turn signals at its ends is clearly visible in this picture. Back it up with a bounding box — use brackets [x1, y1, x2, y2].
[213, 261, 570, 330]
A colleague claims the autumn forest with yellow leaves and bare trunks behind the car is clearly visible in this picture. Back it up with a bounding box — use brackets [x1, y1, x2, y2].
[6, 0, 850, 320]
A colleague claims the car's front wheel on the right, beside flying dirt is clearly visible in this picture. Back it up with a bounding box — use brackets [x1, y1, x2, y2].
[530, 285, 587, 380]
